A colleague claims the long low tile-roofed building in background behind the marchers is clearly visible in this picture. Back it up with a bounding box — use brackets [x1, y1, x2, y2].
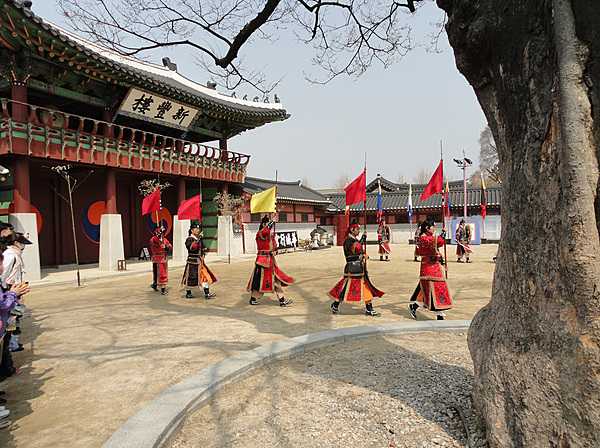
[238, 177, 501, 252]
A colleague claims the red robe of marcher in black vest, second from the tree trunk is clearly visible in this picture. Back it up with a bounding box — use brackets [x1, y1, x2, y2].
[329, 236, 384, 303]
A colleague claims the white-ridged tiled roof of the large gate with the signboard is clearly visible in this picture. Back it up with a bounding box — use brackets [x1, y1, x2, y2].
[5, 0, 289, 123]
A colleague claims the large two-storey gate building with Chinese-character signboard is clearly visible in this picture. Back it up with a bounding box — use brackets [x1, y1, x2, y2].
[0, 0, 288, 279]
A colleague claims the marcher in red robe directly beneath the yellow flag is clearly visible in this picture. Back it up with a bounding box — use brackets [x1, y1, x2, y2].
[247, 215, 294, 306]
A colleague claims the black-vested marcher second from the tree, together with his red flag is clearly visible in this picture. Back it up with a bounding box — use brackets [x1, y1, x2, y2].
[329, 170, 384, 316]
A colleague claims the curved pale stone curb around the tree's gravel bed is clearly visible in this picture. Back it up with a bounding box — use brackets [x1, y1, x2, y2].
[103, 320, 471, 448]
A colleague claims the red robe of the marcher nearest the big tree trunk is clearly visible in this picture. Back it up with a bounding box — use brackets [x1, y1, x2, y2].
[411, 234, 452, 311]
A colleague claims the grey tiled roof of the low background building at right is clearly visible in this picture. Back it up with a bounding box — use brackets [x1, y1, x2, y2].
[328, 185, 502, 211]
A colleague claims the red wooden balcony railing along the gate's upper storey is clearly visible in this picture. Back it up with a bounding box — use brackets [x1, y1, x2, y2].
[0, 98, 250, 182]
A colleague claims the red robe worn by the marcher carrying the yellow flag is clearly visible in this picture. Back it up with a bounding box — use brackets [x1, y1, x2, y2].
[247, 226, 294, 293]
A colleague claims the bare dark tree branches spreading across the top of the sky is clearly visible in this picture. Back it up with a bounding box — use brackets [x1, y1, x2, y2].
[59, 0, 440, 94]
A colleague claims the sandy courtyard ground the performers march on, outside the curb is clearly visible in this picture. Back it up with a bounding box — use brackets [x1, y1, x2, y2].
[0, 245, 497, 448]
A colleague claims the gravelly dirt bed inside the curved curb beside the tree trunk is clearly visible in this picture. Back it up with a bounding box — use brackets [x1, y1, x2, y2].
[170, 332, 475, 448]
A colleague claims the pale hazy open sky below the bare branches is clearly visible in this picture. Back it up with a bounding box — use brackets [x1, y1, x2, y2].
[33, 0, 486, 188]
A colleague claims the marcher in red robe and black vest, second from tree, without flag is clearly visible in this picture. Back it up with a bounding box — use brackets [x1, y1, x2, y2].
[329, 222, 384, 316]
